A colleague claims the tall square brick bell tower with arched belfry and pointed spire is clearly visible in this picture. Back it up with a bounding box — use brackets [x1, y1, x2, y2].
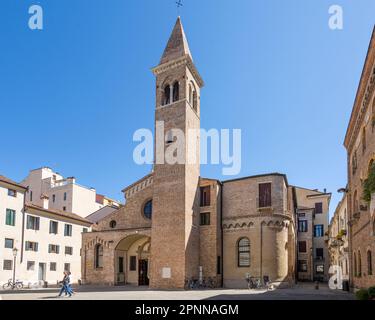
[150, 17, 204, 288]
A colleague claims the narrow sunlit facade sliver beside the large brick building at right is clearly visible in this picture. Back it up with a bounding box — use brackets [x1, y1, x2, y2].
[328, 195, 349, 280]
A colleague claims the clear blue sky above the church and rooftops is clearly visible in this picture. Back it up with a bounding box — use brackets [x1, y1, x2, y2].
[0, 0, 375, 218]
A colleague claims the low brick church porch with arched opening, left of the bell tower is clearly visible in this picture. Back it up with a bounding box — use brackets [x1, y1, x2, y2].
[82, 228, 151, 285]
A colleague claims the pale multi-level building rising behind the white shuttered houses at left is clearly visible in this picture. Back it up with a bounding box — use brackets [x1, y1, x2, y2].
[21, 167, 120, 217]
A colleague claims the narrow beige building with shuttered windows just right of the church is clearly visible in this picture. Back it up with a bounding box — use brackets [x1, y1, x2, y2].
[294, 187, 331, 281]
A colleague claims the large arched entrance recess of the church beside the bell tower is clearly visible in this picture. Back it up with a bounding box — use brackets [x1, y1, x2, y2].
[115, 234, 151, 286]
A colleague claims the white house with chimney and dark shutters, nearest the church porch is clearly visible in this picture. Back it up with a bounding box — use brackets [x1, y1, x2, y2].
[18, 202, 91, 284]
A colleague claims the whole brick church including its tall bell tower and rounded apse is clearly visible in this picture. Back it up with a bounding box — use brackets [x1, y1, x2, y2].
[81, 18, 297, 289]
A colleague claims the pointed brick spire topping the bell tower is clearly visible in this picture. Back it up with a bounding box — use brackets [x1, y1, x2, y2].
[160, 17, 192, 64]
